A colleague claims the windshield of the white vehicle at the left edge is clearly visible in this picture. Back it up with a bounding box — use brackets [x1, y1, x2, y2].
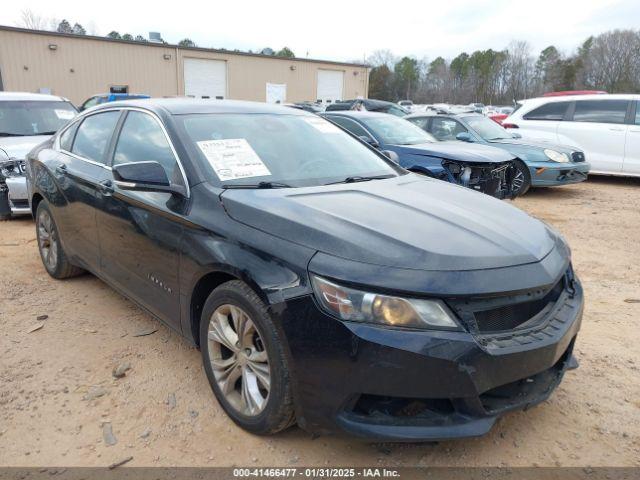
[0, 101, 76, 137]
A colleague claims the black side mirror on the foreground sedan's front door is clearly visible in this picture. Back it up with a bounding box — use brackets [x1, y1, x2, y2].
[113, 162, 186, 195]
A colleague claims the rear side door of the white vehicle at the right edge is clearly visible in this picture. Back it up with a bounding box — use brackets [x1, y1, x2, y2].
[558, 99, 630, 174]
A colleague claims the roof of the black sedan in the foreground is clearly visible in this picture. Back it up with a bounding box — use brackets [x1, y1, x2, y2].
[91, 97, 313, 115]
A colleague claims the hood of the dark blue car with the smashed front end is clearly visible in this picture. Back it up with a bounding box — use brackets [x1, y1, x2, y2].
[394, 141, 513, 163]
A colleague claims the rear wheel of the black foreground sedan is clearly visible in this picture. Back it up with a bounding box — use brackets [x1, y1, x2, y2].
[36, 200, 84, 280]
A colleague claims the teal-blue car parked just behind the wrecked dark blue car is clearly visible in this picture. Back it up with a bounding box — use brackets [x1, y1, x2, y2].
[406, 113, 590, 195]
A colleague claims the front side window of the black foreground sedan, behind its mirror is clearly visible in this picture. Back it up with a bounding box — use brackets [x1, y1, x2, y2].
[113, 111, 184, 184]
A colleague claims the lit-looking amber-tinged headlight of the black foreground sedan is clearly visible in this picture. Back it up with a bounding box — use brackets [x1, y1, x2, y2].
[311, 275, 460, 330]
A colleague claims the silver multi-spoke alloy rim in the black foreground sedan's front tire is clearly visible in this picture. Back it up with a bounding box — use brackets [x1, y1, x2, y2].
[207, 304, 271, 417]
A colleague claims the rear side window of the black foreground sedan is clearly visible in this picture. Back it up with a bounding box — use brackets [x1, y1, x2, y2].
[71, 111, 120, 163]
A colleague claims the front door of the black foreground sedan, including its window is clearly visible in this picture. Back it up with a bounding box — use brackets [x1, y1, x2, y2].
[97, 109, 187, 329]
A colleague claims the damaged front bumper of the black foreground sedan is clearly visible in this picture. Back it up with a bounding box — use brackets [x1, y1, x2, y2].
[280, 268, 583, 441]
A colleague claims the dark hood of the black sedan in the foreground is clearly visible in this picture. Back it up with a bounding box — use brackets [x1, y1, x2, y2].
[222, 174, 555, 271]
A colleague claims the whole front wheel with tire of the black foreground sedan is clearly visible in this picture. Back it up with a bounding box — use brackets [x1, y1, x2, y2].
[200, 280, 295, 435]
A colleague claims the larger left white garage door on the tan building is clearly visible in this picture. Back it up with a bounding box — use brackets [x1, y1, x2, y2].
[184, 58, 227, 99]
